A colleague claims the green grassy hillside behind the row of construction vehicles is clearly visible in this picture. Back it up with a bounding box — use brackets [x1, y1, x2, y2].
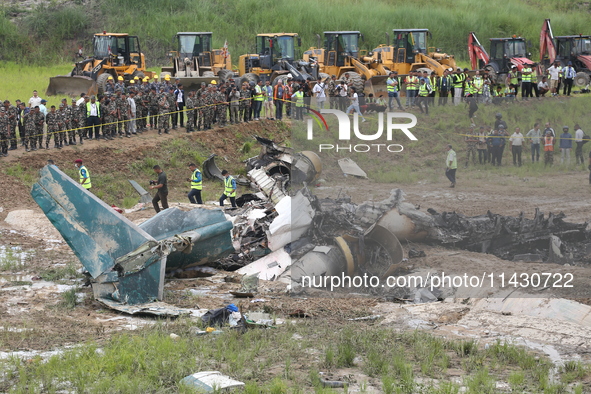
[0, 0, 590, 65]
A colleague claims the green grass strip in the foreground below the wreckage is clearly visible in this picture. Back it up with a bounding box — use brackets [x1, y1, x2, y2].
[0, 320, 588, 394]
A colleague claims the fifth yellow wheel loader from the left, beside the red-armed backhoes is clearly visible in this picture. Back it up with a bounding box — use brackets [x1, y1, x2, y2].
[370, 29, 456, 76]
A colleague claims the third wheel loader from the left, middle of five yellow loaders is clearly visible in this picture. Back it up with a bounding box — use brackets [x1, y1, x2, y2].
[238, 33, 317, 84]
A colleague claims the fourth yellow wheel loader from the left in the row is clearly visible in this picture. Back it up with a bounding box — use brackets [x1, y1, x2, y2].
[303, 31, 388, 92]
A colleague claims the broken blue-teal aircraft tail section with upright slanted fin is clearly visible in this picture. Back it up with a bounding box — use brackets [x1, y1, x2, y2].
[31, 166, 234, 314]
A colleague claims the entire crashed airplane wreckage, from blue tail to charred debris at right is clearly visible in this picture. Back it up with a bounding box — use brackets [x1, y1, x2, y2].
[31, 138, 591, 314]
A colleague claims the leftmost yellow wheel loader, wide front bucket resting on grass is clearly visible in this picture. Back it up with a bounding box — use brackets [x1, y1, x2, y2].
[46, 31, 155, 96]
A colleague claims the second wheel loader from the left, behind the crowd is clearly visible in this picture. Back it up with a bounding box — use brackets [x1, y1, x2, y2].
[160, 32, 234, 91]
